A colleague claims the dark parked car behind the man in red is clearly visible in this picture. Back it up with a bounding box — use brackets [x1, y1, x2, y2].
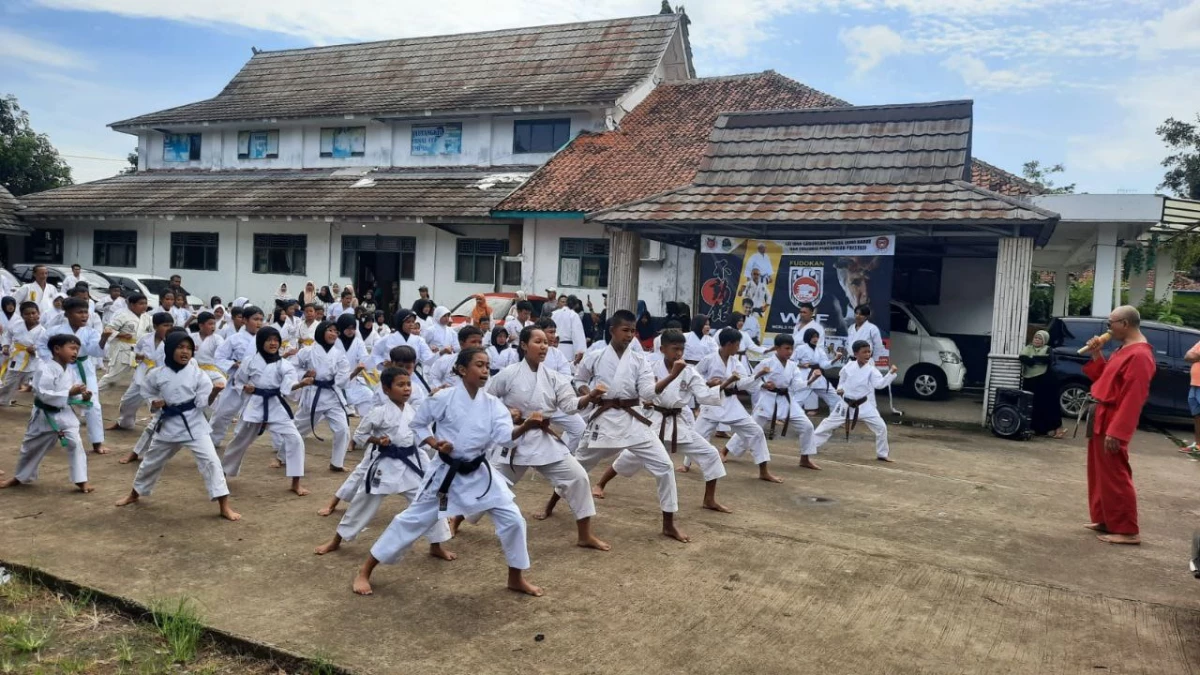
[1050, 316, 1200, 419]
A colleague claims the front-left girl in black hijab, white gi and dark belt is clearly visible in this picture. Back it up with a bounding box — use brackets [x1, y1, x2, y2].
[116, 329, 241, 520]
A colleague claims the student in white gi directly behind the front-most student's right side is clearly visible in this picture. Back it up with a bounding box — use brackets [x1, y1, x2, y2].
[487, 325, 610, 551]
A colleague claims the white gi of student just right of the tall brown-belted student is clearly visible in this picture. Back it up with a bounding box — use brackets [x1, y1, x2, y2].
[612, 359, 725, 483]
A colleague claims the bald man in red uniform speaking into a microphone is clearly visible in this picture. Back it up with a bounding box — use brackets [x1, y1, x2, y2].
[1084, 305, 1156, 544]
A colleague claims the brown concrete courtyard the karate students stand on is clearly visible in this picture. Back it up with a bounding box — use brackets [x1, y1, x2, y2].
[0, 384, 1200, 675]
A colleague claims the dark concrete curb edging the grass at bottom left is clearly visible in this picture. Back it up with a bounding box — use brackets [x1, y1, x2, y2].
[0, 558, 354, 675]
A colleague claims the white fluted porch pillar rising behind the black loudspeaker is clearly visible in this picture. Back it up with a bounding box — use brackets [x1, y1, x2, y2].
[983, 237, 1033, 424]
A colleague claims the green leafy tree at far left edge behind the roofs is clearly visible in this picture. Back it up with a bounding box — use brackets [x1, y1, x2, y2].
[0, 95, 72, 197]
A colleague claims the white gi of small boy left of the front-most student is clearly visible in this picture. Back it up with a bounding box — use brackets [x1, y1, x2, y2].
[337, 400, 450, 544]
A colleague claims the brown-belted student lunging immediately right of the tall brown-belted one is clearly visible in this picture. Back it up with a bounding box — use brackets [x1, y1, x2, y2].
[596, 330, 731, 513]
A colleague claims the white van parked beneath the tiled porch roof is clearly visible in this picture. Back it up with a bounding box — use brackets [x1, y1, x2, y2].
[889, 300, 967, 400]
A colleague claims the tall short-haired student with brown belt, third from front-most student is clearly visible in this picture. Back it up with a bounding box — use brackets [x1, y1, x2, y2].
[568, 310, 690, 542]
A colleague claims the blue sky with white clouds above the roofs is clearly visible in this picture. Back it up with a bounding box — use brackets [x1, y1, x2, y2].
[0, 0, 1200, 193]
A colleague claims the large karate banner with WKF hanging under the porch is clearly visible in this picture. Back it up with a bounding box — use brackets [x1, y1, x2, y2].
[698, 234, 895, 357]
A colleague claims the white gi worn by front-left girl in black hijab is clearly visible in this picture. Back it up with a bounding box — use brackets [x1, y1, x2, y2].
[133, 359, 229, 500]
